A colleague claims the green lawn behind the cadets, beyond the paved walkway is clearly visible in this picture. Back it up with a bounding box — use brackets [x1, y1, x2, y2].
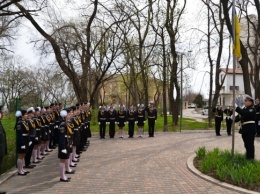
[0, 111, 207, 174]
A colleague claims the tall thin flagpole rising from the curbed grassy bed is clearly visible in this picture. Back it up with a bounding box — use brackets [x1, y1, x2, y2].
[231, 0, 236, 158]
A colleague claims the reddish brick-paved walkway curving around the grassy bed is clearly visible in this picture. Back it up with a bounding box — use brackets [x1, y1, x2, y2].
[0, 131, 260, 194]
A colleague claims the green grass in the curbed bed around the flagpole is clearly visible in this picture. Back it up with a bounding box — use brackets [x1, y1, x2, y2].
[195, 147, 260, 191]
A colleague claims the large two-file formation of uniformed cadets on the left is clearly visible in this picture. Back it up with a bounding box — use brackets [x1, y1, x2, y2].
[15, 102, 91, 182]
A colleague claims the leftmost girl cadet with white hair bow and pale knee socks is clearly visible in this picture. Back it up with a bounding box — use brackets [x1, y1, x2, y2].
[15, 110, 30, 176]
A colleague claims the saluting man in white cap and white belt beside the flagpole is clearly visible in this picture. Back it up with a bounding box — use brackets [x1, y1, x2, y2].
[235, 95, 256, 160]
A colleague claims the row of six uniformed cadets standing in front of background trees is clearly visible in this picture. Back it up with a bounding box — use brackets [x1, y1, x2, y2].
[98, 101, 157, 139]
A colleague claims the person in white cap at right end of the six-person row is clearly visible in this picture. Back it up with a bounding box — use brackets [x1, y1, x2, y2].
[145, 101, 157, 137]
